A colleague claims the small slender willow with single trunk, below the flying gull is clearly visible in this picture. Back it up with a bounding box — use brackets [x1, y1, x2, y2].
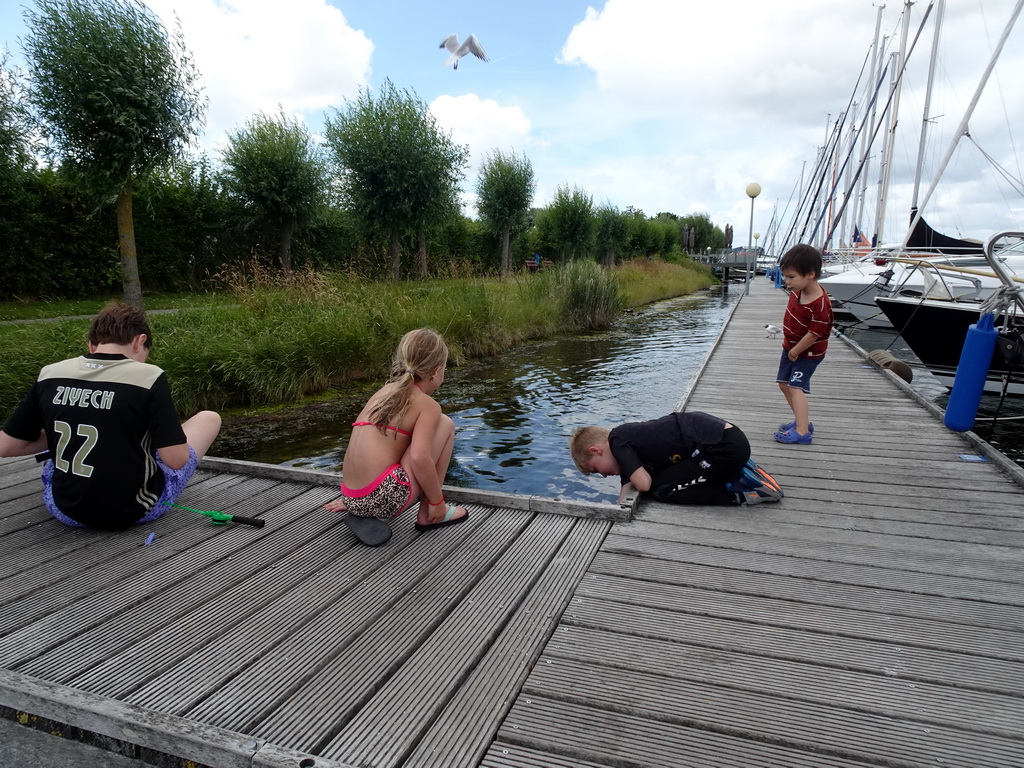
[476, 150, 537, 274]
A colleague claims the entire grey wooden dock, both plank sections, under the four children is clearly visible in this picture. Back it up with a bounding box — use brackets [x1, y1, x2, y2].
[0, 278, 1024, 768]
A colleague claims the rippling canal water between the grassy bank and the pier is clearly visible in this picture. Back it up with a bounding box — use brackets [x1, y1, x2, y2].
[218, 287, 742, 503]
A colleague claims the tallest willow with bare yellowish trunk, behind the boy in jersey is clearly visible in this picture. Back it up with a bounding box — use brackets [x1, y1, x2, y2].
[23, 0, 205, 307]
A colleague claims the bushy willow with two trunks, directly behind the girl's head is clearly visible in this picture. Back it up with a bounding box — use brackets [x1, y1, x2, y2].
[324, 80, 469, 280]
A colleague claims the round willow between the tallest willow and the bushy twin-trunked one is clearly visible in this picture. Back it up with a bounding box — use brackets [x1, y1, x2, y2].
[222, 110, 327, 272]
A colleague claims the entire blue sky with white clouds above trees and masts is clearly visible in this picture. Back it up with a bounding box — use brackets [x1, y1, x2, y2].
[0, 0, 1024, 250]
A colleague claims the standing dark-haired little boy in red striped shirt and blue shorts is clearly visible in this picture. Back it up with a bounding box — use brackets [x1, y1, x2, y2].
[775, 243, 833, 445]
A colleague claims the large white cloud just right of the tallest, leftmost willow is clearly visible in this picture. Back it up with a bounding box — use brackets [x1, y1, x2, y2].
[142, 0, 374, 144]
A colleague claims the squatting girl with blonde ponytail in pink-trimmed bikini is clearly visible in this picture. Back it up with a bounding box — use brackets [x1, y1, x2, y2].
[325, 328, 468, 530]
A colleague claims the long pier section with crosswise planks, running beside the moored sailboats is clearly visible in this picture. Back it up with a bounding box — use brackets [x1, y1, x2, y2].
[481, 281, 1024, 768]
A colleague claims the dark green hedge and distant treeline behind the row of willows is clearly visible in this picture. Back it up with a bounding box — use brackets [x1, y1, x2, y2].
[0, 158, 721, 300]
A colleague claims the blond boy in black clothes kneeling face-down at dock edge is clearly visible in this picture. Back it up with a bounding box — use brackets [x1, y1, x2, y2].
[569, 411, 783, 505]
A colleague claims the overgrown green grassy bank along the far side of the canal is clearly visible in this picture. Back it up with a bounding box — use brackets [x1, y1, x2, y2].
[0, 260, 714, 418]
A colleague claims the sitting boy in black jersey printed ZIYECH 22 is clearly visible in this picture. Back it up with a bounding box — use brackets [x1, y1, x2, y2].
[0, 304, 220, 530]
